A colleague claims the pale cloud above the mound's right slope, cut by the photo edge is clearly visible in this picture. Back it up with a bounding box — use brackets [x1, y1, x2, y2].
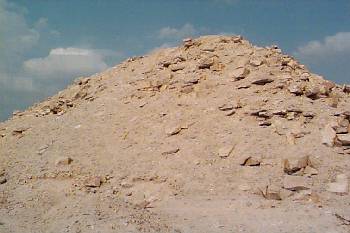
[295, 32, 350, 60]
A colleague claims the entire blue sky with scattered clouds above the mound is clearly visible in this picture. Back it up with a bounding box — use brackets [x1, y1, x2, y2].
[0, 0, 350, 120]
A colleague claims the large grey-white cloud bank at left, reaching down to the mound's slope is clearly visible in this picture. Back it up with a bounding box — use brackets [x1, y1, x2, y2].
[0, 0, 117, 121]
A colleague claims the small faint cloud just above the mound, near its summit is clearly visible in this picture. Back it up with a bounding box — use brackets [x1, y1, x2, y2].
[157, 23, 198, 40]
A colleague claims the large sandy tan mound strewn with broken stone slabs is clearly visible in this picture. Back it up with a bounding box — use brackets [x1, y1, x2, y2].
[0, 36, 350, 233]
